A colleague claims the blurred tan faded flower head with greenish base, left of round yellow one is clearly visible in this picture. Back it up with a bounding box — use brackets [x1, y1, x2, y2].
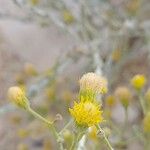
[115, 87, 131, 108]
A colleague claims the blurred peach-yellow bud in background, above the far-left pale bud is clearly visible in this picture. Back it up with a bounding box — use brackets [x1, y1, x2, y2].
[24, 63, 38, 76]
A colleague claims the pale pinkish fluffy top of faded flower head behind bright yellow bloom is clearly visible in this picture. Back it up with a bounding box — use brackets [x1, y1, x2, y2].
[79, 72, 107, 94]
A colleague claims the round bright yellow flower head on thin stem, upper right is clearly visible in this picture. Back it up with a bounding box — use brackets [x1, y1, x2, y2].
[131, 74, 146, 90]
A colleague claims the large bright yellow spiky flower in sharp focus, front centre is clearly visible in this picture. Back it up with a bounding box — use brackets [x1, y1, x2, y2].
[69, 101, 103, 127]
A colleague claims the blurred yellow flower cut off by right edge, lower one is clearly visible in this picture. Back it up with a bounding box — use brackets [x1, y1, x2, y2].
[143, 112, 150, 133]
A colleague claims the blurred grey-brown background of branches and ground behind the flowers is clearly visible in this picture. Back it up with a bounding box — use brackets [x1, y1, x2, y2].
[0, 0, 150, 150]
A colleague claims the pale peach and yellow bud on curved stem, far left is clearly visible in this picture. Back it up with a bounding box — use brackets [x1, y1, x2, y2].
[8, 86, 29, 109]
